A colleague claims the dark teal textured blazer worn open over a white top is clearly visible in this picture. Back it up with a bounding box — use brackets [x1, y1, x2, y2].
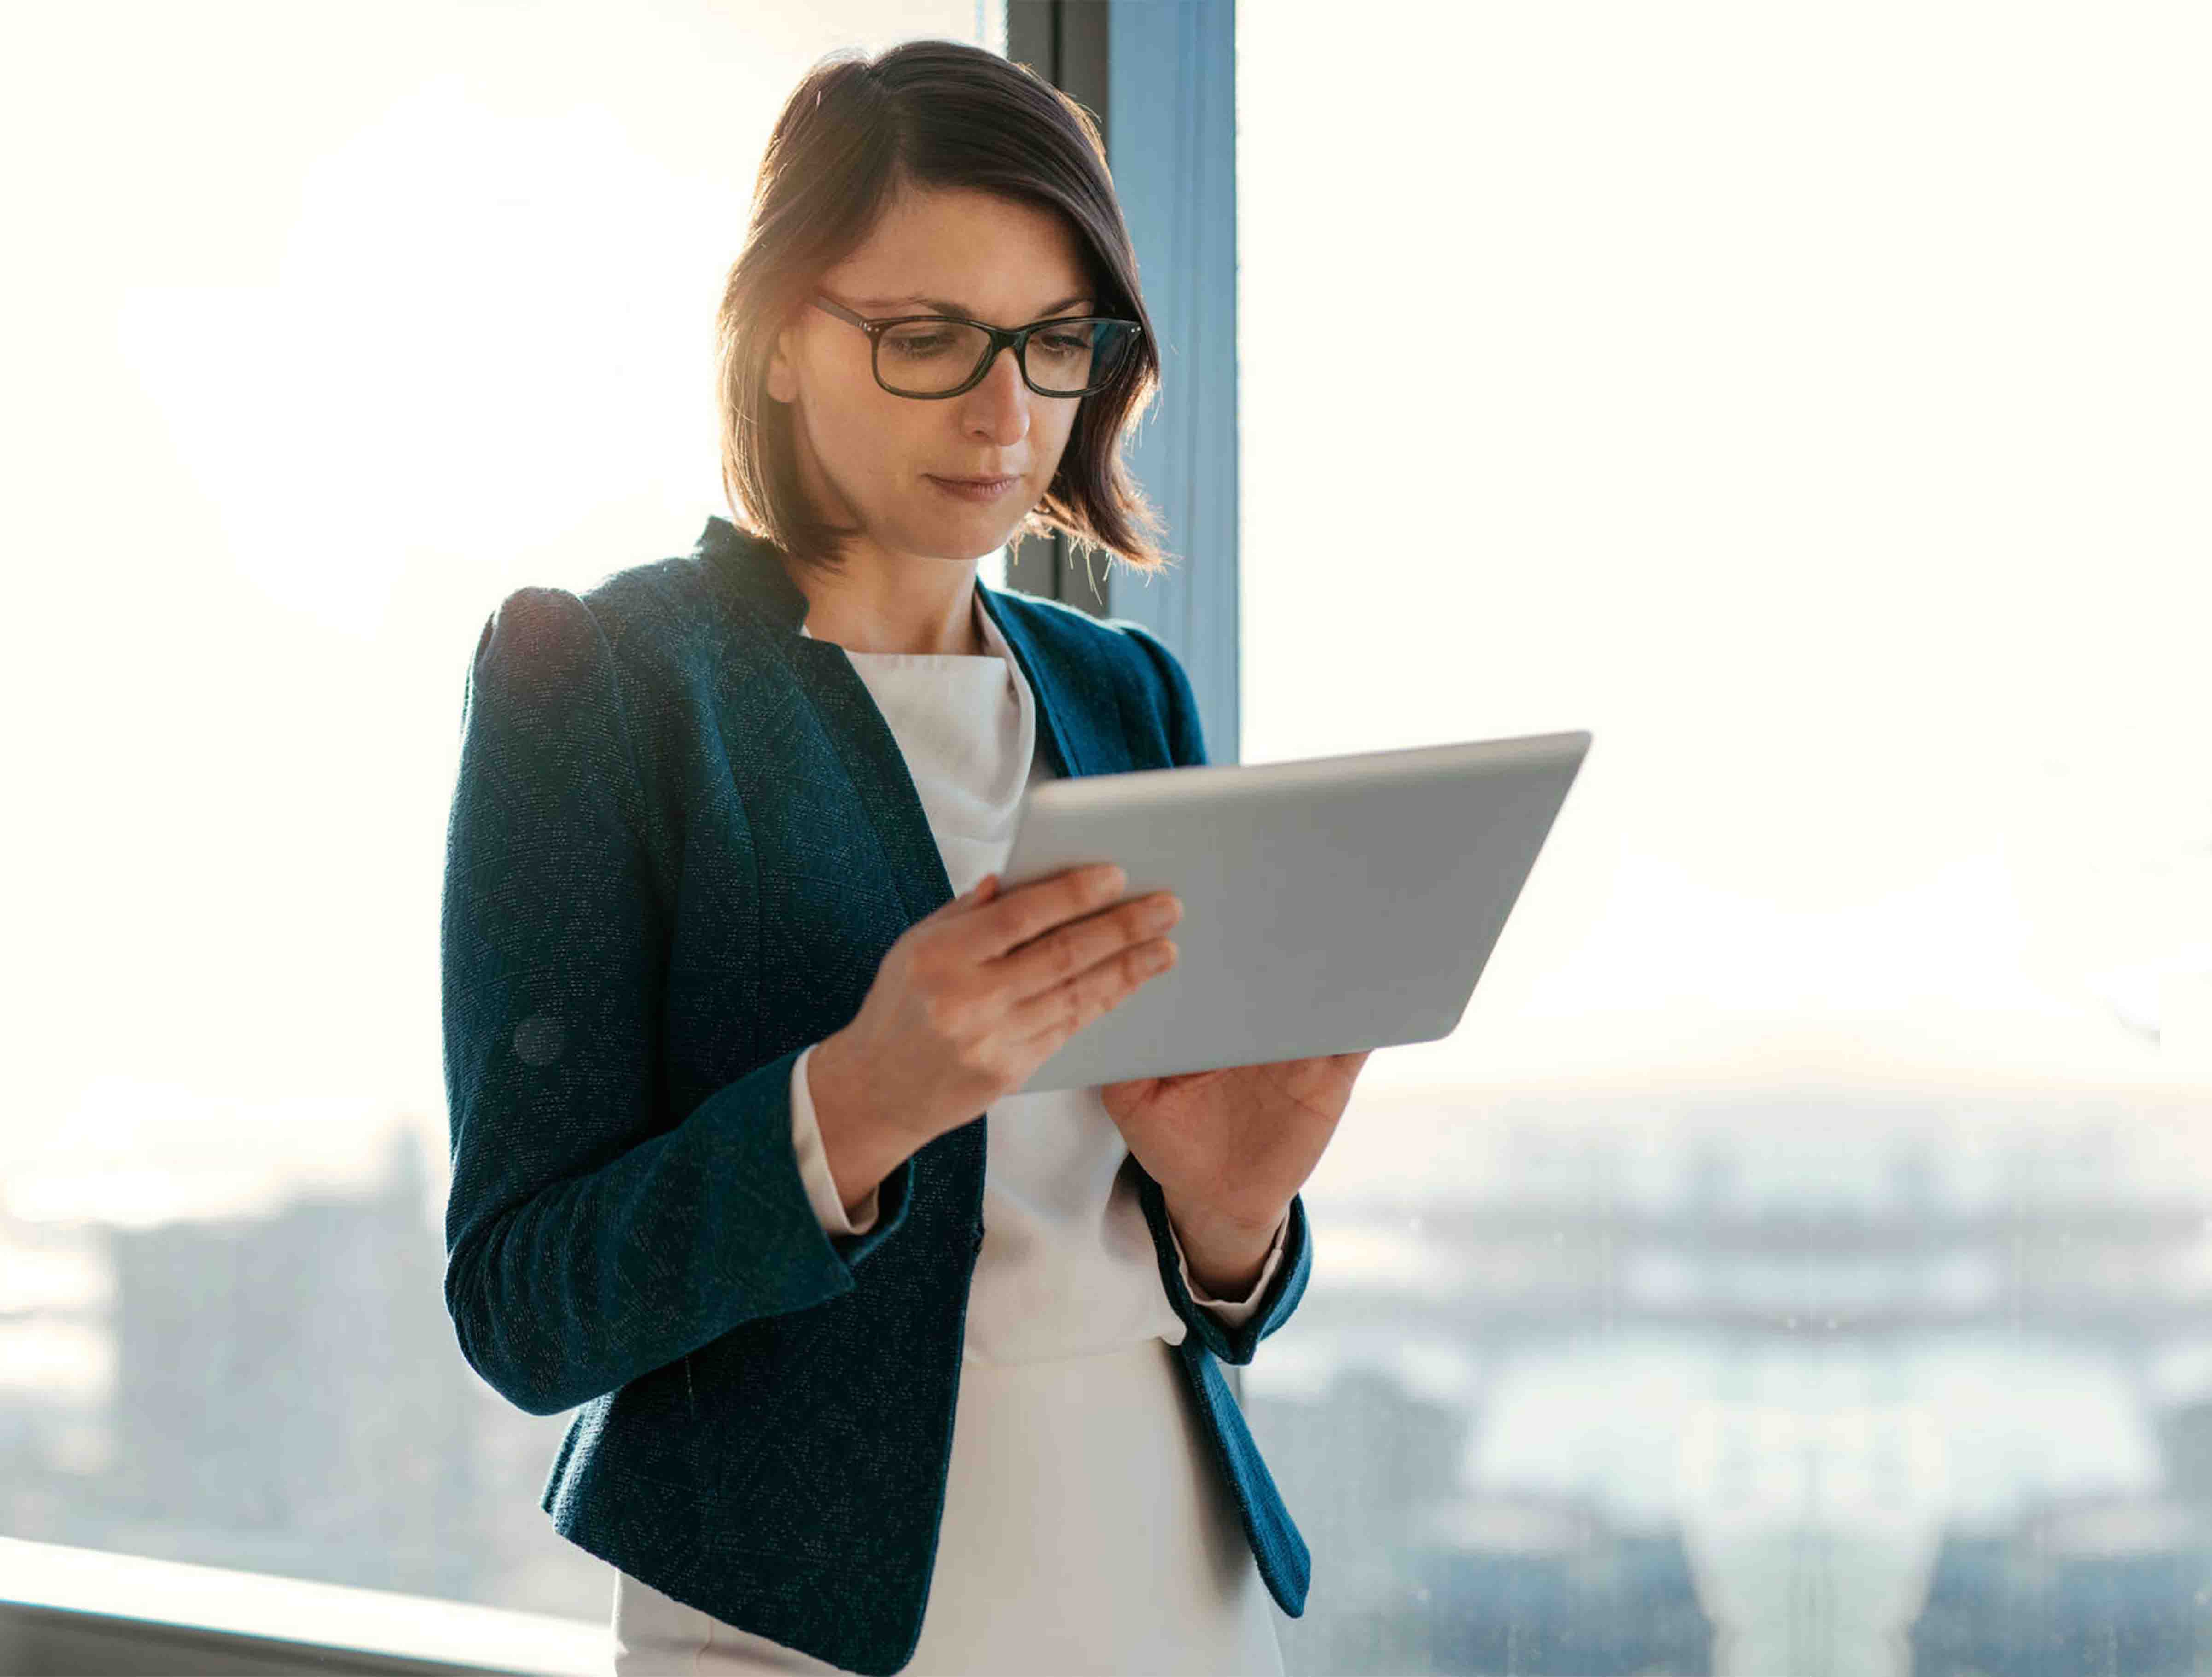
[440, 518, 1312, 1672]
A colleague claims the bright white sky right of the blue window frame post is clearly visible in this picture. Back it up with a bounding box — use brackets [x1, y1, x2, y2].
[1239, 0, 2212, 1086]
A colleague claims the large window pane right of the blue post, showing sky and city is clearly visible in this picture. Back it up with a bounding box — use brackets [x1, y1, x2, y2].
[1236, 0, 2212, 1677]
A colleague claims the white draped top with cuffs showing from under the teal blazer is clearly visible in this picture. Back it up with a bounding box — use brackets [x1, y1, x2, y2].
[792, 586, 1290, 1363]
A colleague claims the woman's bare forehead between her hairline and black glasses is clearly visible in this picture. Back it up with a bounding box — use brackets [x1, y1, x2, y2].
[823, 190, 1090, 321]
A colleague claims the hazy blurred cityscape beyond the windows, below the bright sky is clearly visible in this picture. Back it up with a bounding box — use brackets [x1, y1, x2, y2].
[13, 1084, 2212, 1677]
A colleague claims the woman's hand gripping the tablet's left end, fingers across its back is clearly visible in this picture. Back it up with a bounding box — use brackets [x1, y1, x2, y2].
[809, 863, 1181, 1157]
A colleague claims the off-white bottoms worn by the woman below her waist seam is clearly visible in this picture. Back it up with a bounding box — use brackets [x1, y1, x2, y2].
[615, 1339, 1283, 1672]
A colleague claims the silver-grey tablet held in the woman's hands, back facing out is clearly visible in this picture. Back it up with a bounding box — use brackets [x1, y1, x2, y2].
[1000, 730, 1590, 1095]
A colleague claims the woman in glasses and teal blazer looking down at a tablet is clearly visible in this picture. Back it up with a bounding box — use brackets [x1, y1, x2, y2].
[442, 42, 1367, 1672]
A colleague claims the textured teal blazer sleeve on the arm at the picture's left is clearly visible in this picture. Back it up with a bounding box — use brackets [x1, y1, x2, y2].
[438, 588, 914, 1414]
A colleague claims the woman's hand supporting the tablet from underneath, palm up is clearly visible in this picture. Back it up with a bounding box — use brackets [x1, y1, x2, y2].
[1100, 1048, 1374, 1232]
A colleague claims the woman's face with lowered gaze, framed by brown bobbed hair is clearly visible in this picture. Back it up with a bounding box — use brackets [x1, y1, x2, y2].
[768, 190, 1097, 560]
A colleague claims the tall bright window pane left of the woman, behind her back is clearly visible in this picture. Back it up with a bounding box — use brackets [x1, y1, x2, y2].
[0, 0, 1004, 1626]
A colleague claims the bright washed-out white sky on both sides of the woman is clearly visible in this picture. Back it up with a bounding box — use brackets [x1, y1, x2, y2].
[0, 0, 2212, 1239]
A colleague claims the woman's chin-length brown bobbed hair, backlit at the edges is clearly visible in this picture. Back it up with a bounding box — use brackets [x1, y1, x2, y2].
[716, 40, 1170, 571]
